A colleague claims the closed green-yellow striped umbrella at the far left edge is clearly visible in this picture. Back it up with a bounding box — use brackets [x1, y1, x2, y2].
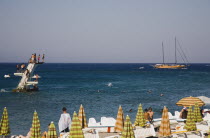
[0, 107, 10, 136]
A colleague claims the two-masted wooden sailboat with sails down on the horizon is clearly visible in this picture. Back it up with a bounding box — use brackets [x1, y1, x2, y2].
[154, 37, 189, 69]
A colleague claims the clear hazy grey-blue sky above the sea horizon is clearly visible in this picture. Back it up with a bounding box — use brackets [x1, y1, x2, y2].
[0, 0, 210, 63]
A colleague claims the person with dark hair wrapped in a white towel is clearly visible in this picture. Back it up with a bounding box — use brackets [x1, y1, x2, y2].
[58, 107, 71, 132]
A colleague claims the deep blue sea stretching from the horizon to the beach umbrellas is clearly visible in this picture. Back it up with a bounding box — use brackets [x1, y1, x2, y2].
[0, 63, 210, 135]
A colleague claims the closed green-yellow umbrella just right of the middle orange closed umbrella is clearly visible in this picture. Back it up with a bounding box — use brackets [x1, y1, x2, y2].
[121, 115, 135, 138]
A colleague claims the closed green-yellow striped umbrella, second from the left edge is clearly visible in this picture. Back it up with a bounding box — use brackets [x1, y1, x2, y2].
[30, 111, 41, 138]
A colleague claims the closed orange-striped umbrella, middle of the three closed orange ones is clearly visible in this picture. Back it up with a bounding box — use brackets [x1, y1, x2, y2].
[114, 105, 124, 132]
